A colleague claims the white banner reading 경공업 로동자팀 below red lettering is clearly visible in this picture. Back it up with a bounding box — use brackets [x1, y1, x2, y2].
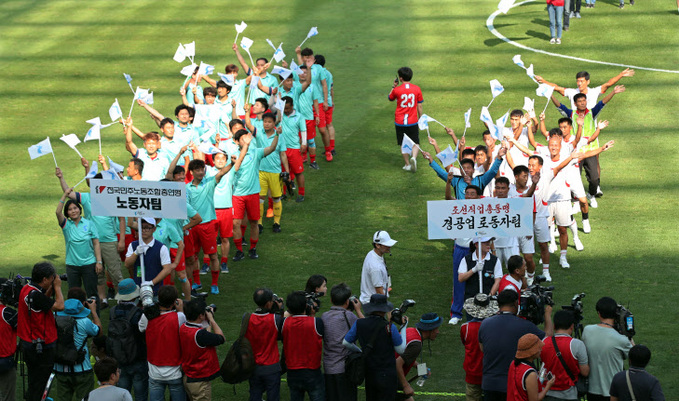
[427, 198, 533, 239]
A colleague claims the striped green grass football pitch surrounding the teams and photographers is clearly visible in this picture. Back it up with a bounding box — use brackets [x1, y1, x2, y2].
[0, 0, 679, 399]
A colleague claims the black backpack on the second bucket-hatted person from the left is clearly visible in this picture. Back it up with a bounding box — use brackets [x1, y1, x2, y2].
[106, 306, 141, 366]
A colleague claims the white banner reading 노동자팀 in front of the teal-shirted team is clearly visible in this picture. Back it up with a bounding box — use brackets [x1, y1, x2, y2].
[90, 180, 186, 219]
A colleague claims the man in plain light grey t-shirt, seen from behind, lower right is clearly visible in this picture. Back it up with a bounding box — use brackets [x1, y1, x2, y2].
[582, 297, 634, 401]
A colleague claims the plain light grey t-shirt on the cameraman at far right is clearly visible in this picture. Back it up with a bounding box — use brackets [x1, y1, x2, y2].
[582, 324, 632, 397]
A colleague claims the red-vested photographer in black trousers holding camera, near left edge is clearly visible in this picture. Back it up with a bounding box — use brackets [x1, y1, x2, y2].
[17, 262, 64, 401]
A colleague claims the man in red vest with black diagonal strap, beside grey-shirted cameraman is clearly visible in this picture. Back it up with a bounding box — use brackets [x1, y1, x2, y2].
[540, 310, 589, 401]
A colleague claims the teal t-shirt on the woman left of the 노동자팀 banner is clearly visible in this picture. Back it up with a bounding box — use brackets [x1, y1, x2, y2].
[61, 217, 99, 266]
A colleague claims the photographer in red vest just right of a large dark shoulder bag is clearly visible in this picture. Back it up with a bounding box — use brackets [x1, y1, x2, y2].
[246, 288, 283, 401]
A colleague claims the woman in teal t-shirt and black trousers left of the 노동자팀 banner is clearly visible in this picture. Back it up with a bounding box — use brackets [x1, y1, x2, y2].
[56, 188, 103, 297]
